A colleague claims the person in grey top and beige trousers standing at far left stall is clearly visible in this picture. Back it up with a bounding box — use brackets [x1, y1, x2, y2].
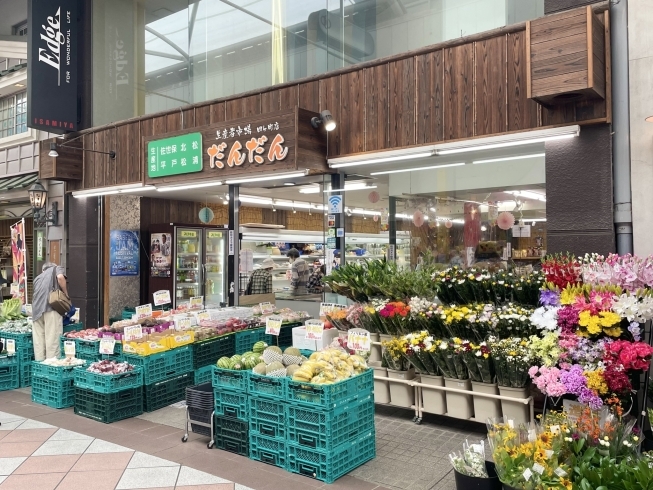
[32, 262, 68, 361]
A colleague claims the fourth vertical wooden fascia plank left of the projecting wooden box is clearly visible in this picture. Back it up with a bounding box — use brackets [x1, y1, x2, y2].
[415, 51, 444, 144]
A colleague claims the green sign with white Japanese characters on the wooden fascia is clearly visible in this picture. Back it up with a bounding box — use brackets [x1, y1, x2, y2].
[147, 133, 202, 178]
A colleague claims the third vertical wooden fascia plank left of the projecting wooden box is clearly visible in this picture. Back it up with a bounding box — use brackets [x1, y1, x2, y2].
[444, 44, 474, 140]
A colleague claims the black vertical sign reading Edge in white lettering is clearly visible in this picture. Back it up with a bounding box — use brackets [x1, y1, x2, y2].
[27, 0, 80, 134]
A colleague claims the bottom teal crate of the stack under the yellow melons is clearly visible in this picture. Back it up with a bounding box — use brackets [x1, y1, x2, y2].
[286, 430, 376, 483]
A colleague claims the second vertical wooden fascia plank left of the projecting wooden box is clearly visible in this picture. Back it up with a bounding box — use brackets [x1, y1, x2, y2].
[474, 36, 508, 136]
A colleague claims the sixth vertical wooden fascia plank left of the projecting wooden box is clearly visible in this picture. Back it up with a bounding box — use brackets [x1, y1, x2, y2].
[364, 65, 390, 151]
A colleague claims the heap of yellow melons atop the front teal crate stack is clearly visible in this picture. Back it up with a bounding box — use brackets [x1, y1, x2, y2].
[292, 349, 367, 384]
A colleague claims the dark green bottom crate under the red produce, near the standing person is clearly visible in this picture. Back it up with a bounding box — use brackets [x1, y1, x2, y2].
[75, 386, 143, 424]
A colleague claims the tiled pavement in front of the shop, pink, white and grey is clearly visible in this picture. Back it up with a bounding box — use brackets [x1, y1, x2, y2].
[0, 389, 484, 490]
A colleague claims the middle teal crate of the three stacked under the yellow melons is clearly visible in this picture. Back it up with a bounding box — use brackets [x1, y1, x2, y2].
[286, 395, 374, 451]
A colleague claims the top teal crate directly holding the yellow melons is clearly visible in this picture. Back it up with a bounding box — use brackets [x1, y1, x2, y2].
[286, 369, 374, 410]
